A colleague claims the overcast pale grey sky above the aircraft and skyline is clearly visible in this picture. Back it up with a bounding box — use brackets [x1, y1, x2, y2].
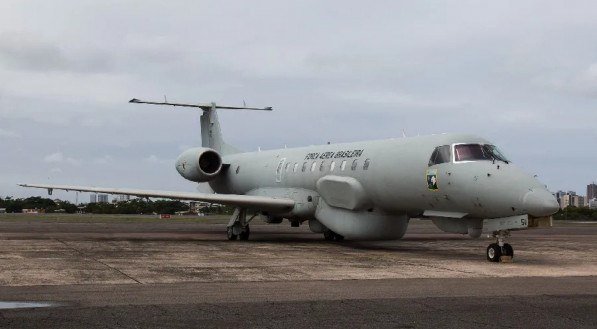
[0, 0, 597, 201]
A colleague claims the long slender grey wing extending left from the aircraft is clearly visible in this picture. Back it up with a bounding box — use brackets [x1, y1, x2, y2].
[19, 184, 295, 210]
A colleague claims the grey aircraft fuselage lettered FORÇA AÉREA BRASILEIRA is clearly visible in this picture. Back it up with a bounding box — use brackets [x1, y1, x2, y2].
[210, 134, 557, 223]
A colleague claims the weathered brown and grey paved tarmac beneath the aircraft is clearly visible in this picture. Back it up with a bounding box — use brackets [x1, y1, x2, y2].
[0, 217, 597, 328]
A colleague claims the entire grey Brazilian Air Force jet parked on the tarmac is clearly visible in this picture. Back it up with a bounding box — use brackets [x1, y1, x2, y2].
[19, 99, 559, 262]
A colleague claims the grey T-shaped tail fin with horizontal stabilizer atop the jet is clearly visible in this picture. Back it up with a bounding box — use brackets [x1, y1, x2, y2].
[129, 98, 272, 155]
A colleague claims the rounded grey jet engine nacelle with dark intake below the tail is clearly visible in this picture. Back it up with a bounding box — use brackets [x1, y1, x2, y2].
[176, 147, 222, 183]
